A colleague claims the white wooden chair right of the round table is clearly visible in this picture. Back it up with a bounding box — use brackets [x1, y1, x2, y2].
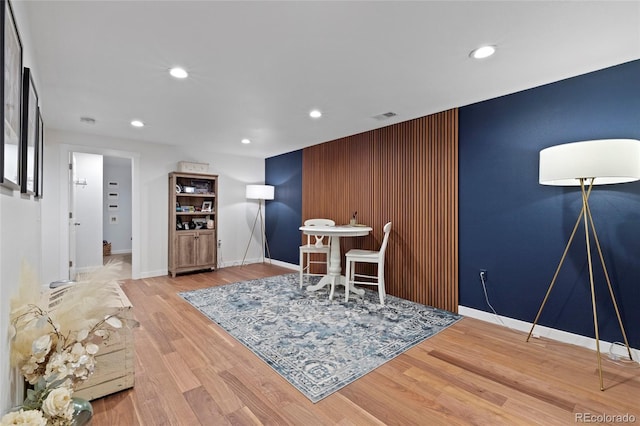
[344, 222, 391, 305]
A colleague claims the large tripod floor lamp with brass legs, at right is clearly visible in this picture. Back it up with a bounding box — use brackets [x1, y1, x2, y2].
[527, 139, 640, 390]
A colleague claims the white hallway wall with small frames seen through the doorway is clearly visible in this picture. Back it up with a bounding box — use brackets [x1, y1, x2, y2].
[102, 157, 132, 254]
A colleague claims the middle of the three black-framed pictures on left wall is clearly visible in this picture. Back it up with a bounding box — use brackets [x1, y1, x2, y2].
[20, 67, 38, 195]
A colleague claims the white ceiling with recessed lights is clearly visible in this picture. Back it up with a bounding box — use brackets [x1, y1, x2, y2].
[20, 0, 640, 158]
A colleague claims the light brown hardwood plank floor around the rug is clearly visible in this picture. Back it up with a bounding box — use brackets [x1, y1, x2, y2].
[92, 264, 640, 426]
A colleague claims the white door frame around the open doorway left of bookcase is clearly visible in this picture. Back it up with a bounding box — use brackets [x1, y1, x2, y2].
[58, 144, 141, 280]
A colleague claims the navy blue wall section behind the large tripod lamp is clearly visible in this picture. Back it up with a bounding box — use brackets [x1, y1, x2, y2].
[459, 61, 640, 348]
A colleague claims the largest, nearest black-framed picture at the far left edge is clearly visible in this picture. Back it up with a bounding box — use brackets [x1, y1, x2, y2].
[0, 0, 22, 189]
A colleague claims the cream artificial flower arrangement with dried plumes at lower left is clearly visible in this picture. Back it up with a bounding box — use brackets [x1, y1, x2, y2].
[0, 265, 130, 426]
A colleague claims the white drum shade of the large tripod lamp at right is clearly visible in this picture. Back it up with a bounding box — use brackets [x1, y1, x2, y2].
[539, 139, 640, 186]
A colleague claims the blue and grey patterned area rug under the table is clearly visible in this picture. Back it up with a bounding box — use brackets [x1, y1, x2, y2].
[179, 274, 462, 403]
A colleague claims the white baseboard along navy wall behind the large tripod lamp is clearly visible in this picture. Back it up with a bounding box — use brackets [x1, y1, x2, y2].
[458, 306, 640, 362]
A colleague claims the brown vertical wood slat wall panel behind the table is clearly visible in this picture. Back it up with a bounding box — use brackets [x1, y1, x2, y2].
[302, 109, 458, 312]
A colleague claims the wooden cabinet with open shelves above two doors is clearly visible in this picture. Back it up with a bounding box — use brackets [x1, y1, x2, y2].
[168, 172, 218, 277]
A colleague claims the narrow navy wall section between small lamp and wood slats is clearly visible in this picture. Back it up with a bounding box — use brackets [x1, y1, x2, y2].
[265, 150, 302, 265]
